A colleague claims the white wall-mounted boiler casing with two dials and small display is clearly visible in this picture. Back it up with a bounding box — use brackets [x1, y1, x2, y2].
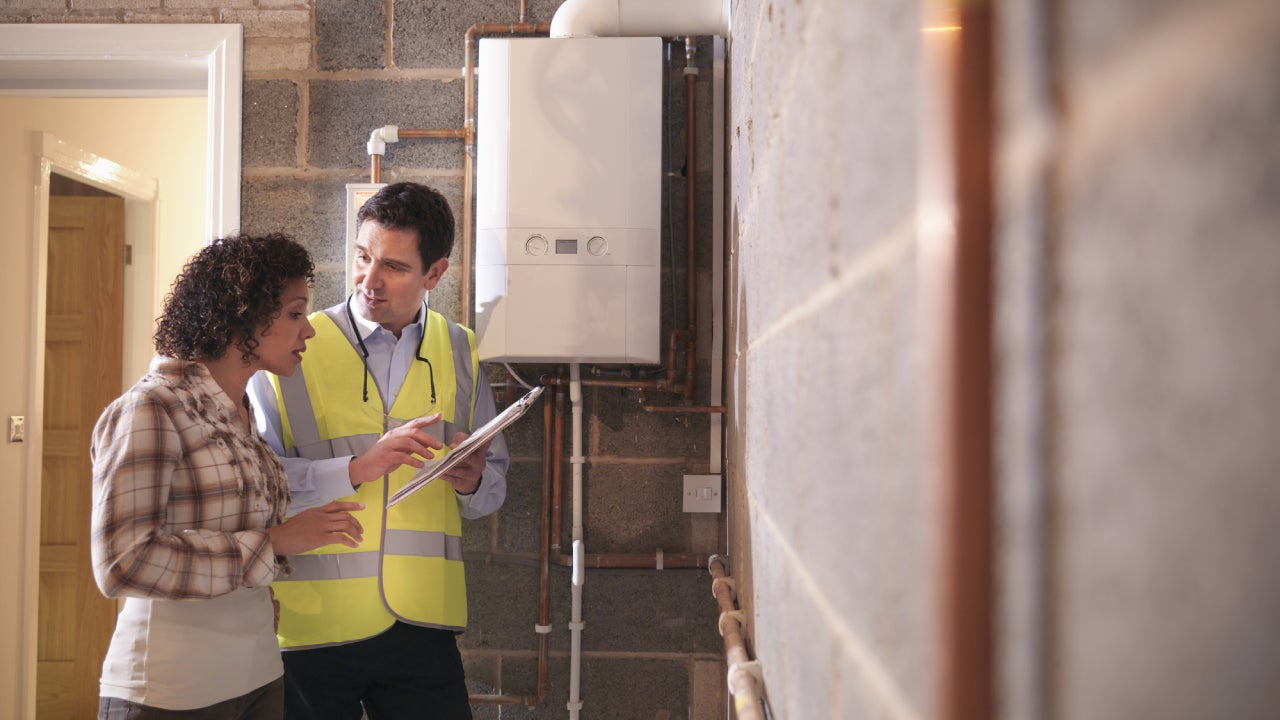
[475, 37, 662, 363]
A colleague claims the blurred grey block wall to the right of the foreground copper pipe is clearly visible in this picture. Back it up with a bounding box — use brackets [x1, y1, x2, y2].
[998, 0, 1280, 719]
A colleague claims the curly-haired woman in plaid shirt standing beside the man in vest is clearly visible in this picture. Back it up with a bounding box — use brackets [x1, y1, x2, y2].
[92, 234, 364, 720]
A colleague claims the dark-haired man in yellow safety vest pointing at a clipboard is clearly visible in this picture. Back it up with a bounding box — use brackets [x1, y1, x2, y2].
[252, 182, 508, 720]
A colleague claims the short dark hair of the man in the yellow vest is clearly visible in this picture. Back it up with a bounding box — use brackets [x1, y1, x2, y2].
[356, 182, 453, 273]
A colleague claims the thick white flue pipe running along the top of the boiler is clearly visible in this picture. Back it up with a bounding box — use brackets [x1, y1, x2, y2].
[550, 0, 730, 37]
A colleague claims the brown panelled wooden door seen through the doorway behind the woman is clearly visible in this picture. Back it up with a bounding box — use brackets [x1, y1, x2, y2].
[36, 192, 124, 720]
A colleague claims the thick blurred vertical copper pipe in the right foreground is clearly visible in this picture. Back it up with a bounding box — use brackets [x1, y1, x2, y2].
[941, 0, 995, 720]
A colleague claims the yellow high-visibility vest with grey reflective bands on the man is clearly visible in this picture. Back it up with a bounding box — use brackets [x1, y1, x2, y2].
[271, 307, 479, 650]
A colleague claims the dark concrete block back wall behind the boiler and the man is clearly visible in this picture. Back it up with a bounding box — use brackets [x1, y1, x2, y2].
[0, 0, 726, 719]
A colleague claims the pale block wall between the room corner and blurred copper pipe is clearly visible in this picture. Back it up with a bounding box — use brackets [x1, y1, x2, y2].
[728, 0, 938, 719]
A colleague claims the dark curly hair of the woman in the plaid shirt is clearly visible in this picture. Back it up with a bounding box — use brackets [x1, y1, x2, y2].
[155, 233, 315, 363]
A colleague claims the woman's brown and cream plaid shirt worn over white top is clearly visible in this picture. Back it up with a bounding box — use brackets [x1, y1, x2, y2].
[91, 357, 289, 598]
